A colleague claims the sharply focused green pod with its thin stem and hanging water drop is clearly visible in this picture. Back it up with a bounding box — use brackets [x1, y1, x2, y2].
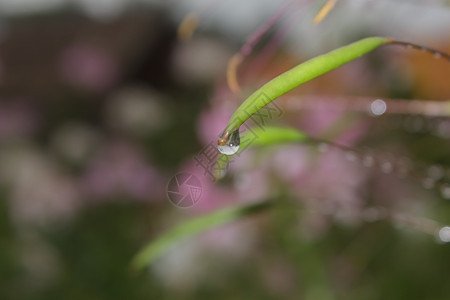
[218, 37, 450, 155]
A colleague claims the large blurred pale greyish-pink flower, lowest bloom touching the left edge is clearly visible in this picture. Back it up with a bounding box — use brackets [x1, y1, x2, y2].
[0, 144, 80, 226]
